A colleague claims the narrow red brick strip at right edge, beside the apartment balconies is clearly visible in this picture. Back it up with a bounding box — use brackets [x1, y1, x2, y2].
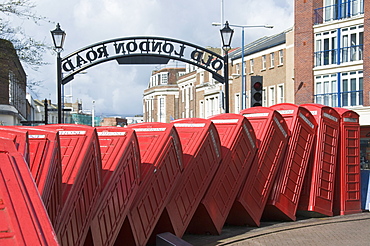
[363, 1, 370, 106]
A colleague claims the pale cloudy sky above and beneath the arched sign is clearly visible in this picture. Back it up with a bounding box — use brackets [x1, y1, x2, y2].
[8, 0, 294, 116]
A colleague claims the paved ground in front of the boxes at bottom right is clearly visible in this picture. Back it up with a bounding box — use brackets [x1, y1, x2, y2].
[183, 212, 370, 246]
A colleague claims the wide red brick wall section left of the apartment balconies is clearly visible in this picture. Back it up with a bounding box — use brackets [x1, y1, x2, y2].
[294, 0, 323, 104]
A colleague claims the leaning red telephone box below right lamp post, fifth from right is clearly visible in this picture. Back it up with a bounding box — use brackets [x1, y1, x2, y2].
[187, 114, 257, 234]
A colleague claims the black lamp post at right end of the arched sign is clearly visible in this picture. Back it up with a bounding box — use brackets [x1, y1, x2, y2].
[220, 21, 234, 113]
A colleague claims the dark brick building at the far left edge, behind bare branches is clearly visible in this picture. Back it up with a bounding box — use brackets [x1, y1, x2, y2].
[0, 39, 27, 125]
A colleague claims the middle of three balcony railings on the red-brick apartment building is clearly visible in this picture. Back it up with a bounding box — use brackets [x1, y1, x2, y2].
[314, 44, 363, 67]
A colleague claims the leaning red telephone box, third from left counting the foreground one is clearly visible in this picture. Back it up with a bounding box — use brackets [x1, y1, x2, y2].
[20, 127, 62, 227]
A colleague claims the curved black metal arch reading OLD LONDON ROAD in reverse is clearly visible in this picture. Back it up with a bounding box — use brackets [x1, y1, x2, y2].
[61, 36, 224, 84]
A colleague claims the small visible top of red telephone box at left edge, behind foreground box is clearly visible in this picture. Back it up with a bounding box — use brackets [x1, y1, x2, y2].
[0, 126, 30, 163]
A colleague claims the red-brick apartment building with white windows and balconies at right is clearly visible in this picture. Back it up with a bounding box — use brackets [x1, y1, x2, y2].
[294, 0, 370, 165]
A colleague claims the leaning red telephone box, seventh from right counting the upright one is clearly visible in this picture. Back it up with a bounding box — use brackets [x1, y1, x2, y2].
[123, 122, 183, 245]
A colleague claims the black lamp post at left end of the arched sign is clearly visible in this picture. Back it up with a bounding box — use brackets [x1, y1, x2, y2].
[50, 23, 66, 124]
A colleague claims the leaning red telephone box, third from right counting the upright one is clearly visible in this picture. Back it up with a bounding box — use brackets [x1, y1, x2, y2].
[263, 103, 317, 220]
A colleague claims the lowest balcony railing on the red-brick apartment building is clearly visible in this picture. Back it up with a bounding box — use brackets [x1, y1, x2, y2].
[315, 90, 363, 107]
